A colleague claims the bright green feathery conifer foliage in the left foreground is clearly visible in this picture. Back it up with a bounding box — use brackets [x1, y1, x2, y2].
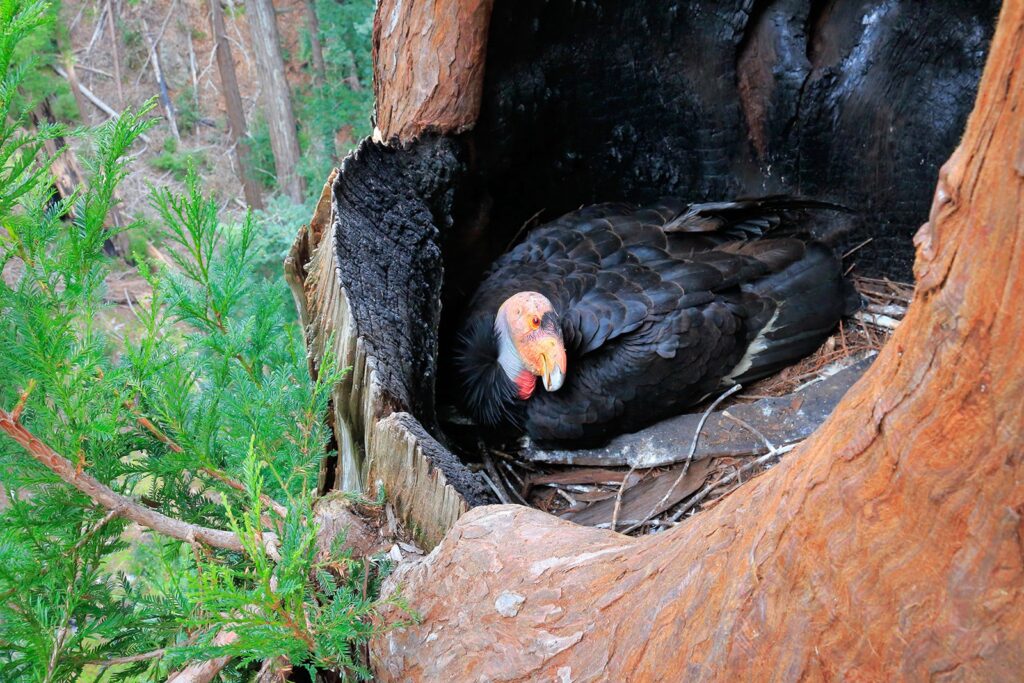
[0, 0, 405, 682]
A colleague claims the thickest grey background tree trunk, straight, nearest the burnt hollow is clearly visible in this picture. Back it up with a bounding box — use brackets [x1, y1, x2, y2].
[246, 0, 305, 202]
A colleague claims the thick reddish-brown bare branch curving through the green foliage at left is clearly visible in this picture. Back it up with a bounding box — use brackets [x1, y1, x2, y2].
[0, 410, 264, 552]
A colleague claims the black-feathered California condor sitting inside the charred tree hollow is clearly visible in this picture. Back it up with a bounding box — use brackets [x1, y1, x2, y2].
[457, 197, 850, 445]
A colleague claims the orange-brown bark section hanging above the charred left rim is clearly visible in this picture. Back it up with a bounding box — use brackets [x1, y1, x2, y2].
[374, 0, 494, 141]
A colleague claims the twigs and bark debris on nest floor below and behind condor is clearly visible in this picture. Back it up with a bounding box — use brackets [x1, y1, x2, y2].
[471, 278, 913, 535]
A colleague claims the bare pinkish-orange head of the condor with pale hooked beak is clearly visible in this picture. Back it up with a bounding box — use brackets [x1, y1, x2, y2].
[495, 292, 565, 400]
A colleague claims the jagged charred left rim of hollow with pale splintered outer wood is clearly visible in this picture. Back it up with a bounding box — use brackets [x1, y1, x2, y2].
[285, 138, 494, 546]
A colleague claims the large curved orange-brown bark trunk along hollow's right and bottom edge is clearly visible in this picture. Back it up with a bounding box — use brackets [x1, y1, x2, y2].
[373, 0, 1024, 681]
